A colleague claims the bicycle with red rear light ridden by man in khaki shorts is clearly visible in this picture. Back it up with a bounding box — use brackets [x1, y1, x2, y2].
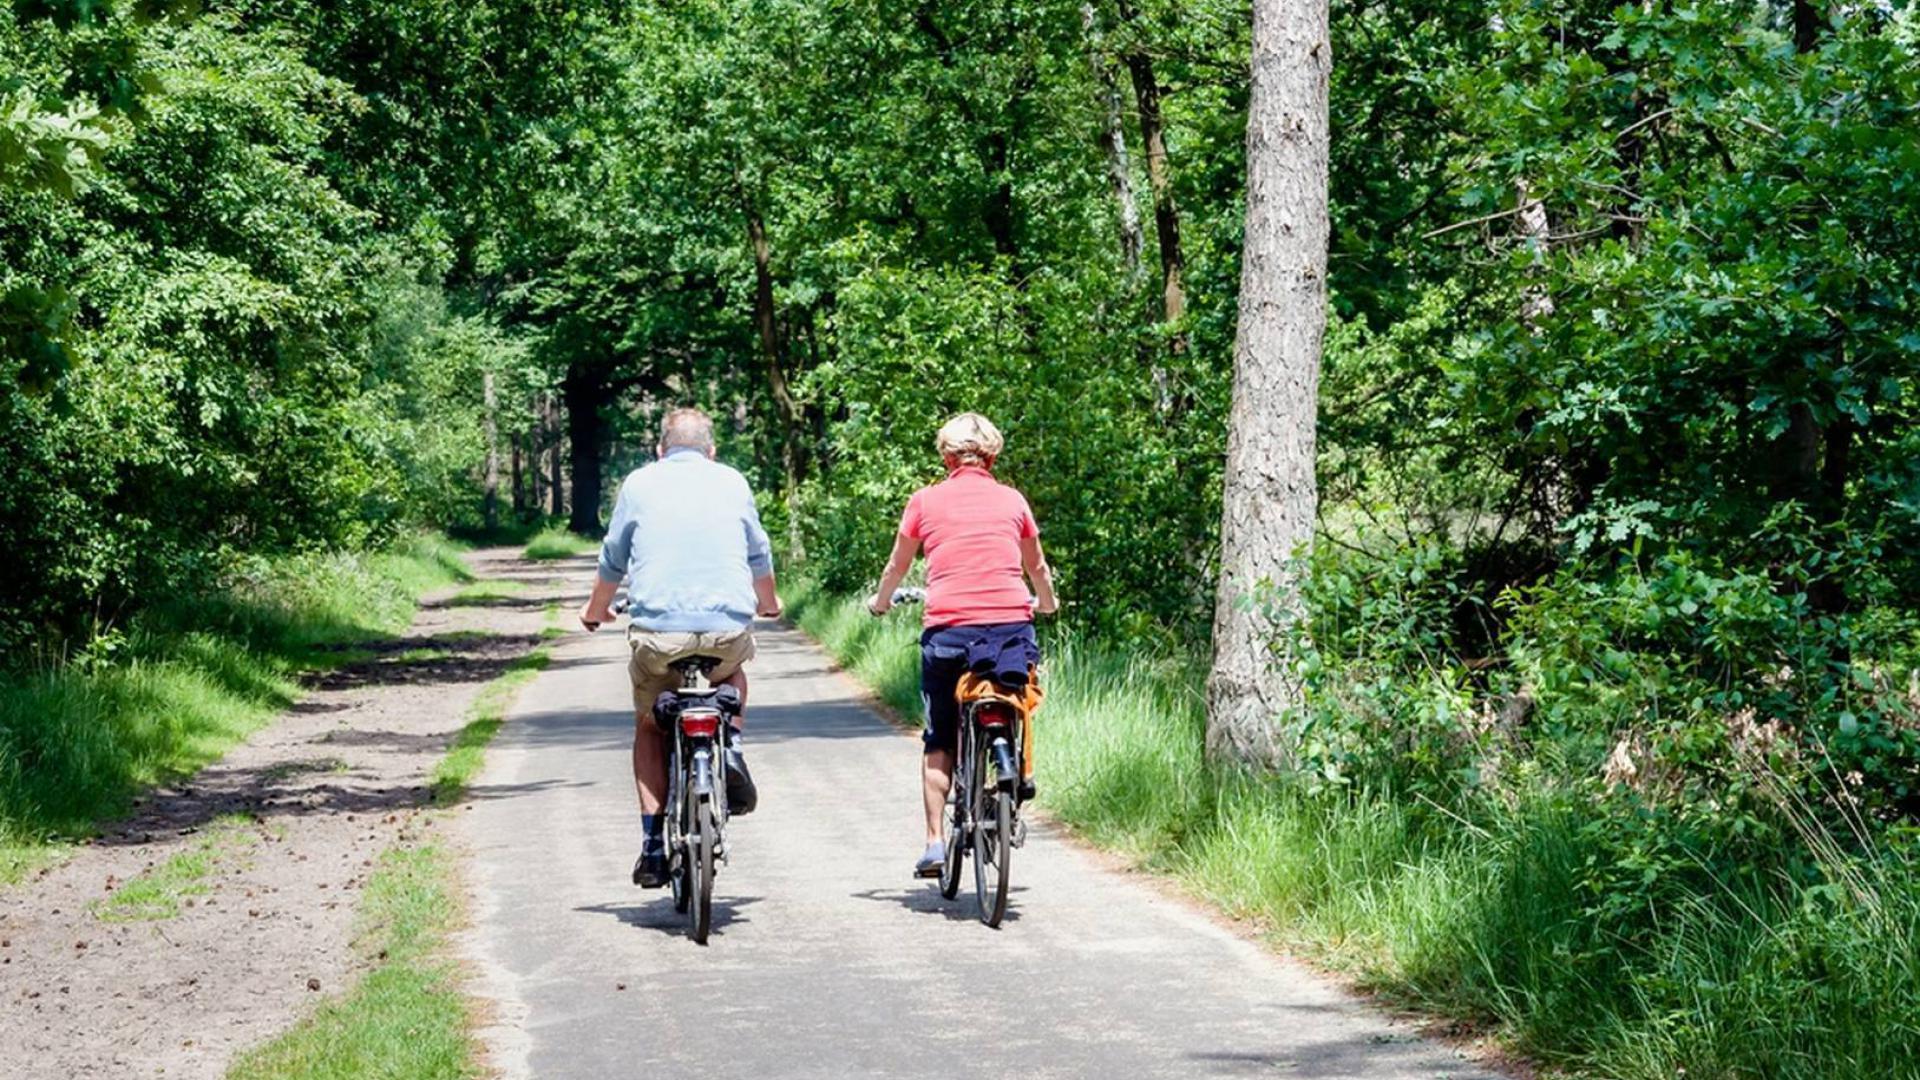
[653, 655, 741, 945]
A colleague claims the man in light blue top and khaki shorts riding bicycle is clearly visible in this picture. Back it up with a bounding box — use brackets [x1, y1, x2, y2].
[580, 409, 780, 888]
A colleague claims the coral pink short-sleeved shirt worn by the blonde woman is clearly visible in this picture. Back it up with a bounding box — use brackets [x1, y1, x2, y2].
[900, 465, 1041, 626]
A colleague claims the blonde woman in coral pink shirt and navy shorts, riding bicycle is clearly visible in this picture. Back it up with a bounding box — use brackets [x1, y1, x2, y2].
[868, 413, 1060, 878]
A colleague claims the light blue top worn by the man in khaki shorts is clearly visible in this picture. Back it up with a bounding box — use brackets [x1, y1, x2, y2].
[599, 450, 774, 632]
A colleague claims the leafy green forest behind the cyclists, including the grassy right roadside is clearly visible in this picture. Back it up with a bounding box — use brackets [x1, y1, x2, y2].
[0, 0, 1920, 1076]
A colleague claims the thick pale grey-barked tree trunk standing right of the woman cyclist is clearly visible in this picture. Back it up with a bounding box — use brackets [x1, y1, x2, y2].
[1206, 0, 1332, 765]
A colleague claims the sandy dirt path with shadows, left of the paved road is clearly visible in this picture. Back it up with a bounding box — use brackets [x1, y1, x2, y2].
[0, 550, 560, 1080]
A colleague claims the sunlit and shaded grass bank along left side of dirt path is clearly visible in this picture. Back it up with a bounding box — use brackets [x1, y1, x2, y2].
[0, 536, 470, 882]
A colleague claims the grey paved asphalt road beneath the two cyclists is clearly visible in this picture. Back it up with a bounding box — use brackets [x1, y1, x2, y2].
[461, 611, 1486, 1080]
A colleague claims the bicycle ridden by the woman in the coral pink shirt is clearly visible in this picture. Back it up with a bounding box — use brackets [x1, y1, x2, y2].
[893, 588, 1027, 928]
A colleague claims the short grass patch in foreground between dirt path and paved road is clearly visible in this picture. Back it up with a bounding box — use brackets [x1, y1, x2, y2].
[227, 846, 482, 1080]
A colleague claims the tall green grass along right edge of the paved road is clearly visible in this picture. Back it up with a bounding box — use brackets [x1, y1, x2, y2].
[789, 582, 1920, 1080]
